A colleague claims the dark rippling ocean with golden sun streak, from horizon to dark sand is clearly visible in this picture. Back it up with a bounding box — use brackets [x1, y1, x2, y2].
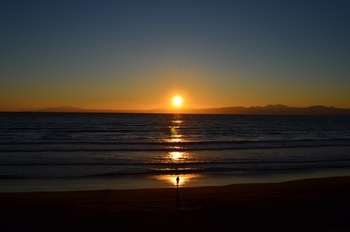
[0, 113, 350, 192]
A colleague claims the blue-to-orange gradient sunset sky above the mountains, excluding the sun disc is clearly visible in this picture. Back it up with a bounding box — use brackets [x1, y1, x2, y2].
[0, 0, 350, 111]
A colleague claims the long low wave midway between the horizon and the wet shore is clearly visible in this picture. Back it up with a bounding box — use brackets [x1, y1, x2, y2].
[0, 138, 350, 152]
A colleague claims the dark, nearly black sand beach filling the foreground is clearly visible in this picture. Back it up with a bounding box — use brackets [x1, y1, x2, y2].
[0, 177, 350, 232]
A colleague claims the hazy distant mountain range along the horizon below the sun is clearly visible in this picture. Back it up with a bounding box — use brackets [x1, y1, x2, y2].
[37, 104, 350, 116]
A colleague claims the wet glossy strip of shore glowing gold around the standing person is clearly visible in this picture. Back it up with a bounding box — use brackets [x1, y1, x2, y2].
[0, 168, 350, 193]
